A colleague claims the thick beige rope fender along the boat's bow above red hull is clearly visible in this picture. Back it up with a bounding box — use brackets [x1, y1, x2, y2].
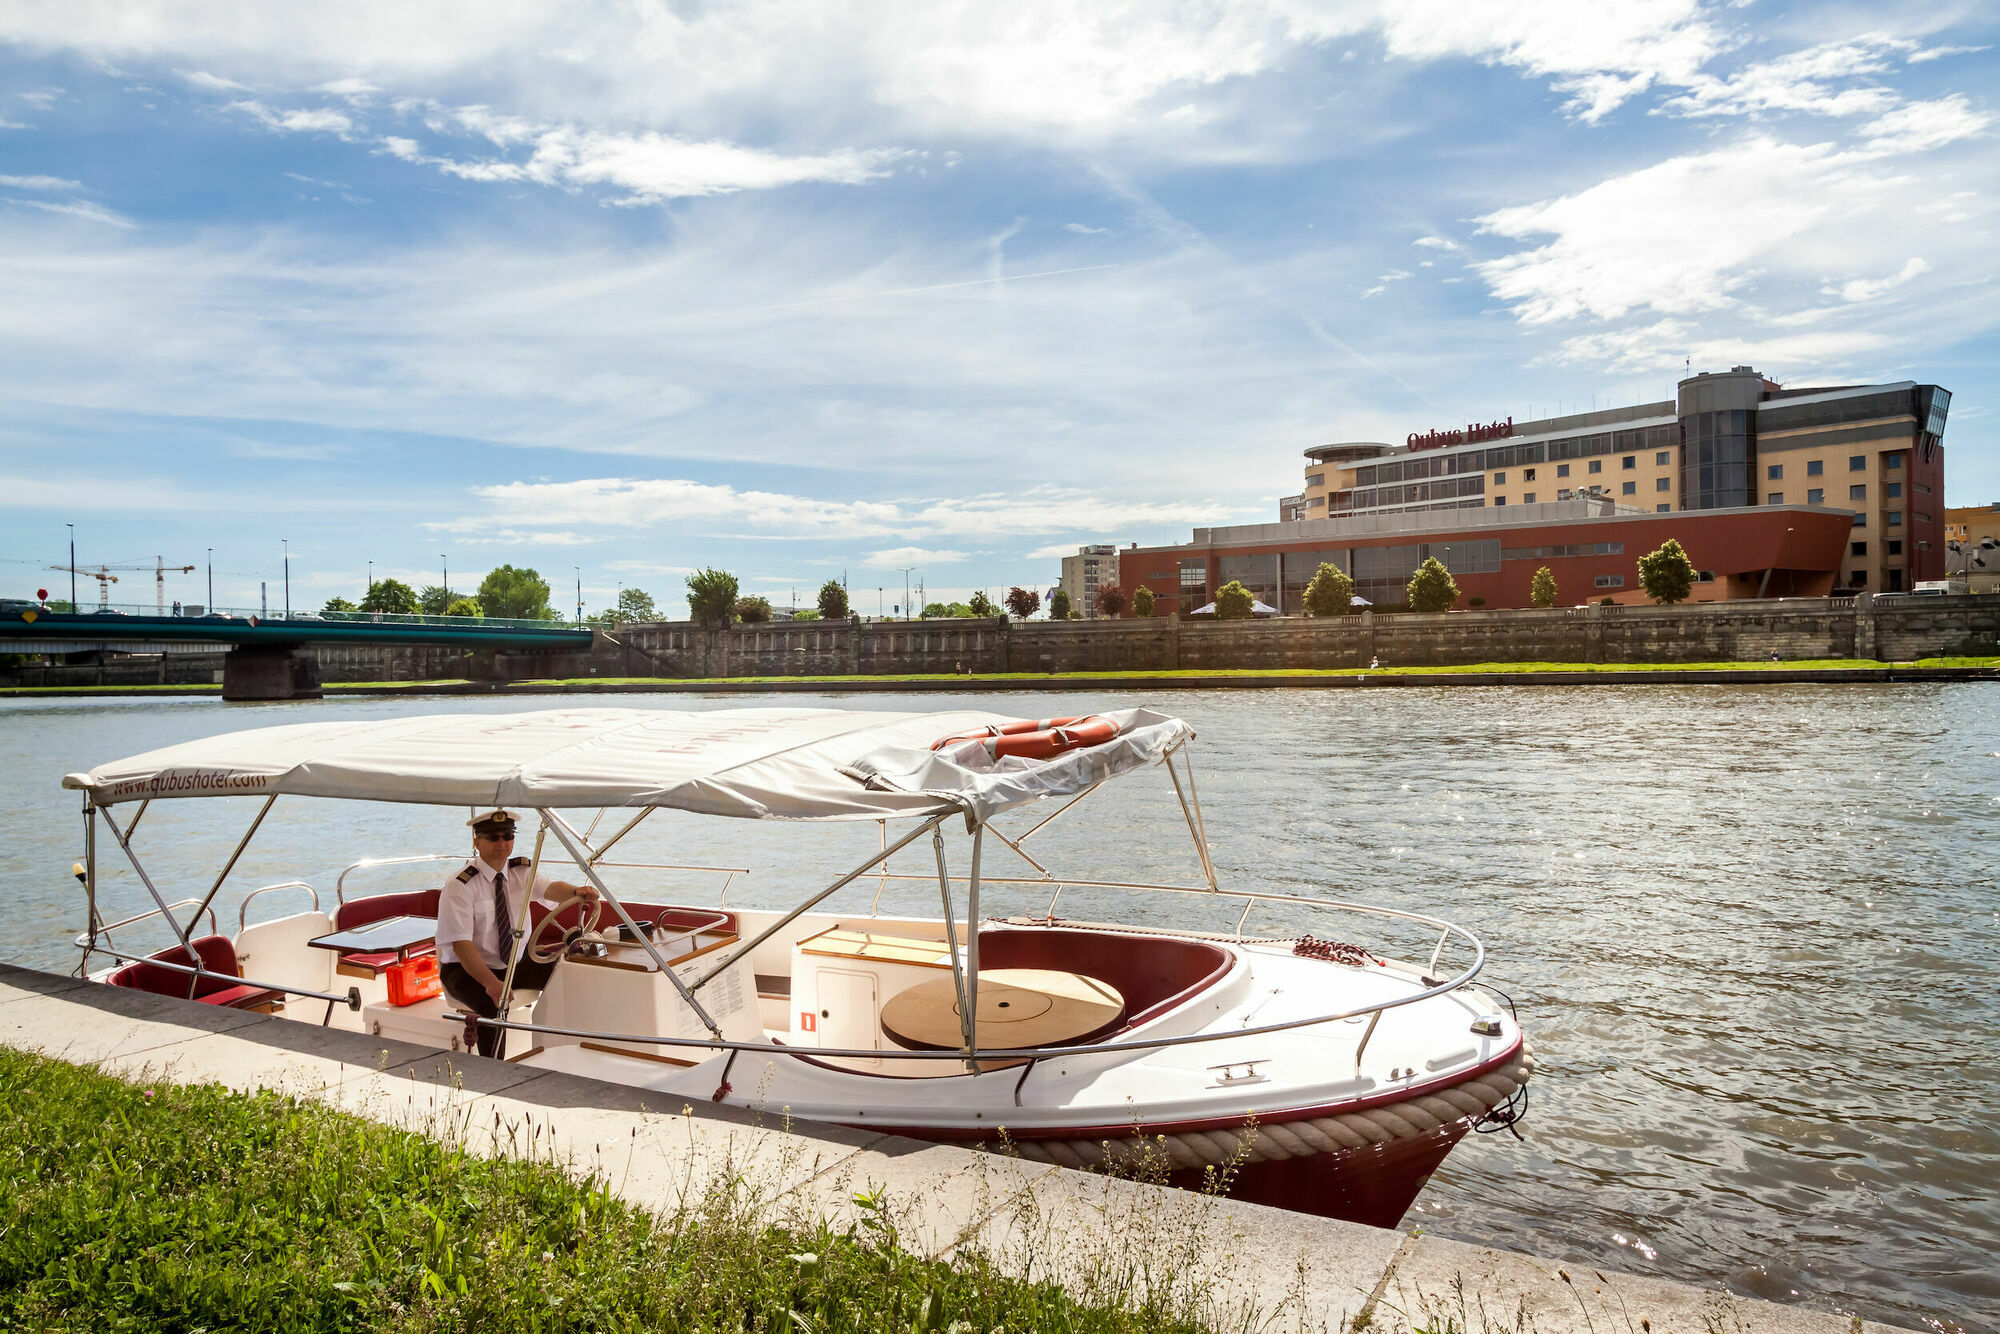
[1012, 1038, 1534, 1168]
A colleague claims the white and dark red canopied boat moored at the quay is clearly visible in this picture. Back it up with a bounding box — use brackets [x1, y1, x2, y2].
[64, 708, 1532, 1226]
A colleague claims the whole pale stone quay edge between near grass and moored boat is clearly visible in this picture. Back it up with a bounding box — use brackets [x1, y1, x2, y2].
[0, 964, 1890, 1334]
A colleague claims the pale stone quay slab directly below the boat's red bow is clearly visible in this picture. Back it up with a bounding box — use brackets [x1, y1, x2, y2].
[966, 1168, 1404, 1330]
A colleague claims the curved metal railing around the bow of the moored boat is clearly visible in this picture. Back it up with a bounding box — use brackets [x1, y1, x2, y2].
[478, 888, 1486, 1072]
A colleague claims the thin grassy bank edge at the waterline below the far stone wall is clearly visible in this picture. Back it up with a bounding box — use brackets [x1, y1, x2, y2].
[0, 666, 2000, 700]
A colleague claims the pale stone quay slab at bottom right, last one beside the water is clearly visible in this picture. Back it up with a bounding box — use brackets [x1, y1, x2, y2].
[1372, 1236, 1854, 1334]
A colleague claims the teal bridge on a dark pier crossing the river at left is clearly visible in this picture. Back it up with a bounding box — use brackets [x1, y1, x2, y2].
[0, 600, 594, 700]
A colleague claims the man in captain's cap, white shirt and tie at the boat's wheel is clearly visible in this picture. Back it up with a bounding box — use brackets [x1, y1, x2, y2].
[438, 810, 598, 1056]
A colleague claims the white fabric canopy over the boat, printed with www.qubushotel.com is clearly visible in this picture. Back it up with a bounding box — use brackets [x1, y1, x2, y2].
[62, 708, 1194, 822]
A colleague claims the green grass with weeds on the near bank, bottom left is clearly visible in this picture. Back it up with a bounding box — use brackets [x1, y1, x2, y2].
[0, 1048, 1280, 1334]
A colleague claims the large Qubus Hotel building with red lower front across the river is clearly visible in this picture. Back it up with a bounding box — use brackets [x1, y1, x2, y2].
[1120, 366, 1952, 614]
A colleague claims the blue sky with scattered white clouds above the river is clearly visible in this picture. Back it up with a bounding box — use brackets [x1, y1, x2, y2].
[0, 0, 2000, 616]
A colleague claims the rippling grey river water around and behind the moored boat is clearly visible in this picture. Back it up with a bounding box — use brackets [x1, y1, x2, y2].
[0, 684, 2000, 1332]
